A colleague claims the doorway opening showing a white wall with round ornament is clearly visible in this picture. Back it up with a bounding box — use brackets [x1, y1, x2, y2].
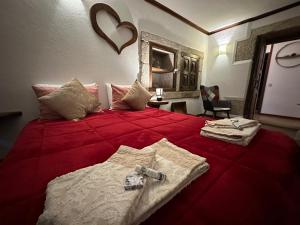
[256, 39, 300, 119]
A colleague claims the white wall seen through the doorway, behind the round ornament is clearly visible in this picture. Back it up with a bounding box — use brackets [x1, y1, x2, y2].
[261, 39, 300, 118]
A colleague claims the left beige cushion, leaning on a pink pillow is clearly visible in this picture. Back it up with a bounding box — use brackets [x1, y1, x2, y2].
[38, 79, 99, 120]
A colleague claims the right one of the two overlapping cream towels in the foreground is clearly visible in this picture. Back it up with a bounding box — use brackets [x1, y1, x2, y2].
[132, 139, 209, 224]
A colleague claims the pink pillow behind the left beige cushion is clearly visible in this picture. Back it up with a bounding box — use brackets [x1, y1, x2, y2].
[32, 83, 102, 120]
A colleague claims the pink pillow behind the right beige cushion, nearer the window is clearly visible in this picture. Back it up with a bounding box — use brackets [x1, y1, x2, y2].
[111, 84, 130, 110]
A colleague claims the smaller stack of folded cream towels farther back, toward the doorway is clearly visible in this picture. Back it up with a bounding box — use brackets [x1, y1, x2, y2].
[200, 118, 261, 146]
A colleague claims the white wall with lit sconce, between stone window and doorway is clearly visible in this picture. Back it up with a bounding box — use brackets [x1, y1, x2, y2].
[203, 6, 300, 98]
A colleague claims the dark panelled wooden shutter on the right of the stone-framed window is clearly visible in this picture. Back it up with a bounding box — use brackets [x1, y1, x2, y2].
[180, 53, 200, 91]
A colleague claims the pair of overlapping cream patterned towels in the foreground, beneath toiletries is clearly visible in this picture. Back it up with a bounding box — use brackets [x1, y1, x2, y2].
[37, 139, 209, 225]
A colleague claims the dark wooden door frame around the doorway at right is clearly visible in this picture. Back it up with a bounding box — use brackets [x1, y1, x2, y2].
[244, 26, 300, 119]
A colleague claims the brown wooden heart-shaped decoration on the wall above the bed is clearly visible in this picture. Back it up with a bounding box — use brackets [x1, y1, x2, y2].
[90, 3, 138, 54]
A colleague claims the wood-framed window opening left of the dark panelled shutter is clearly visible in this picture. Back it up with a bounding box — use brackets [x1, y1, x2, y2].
[149, 42, 177, 91]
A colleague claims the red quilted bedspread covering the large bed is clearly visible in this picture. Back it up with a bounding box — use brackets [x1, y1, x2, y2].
[0, 108, 300, 225]
